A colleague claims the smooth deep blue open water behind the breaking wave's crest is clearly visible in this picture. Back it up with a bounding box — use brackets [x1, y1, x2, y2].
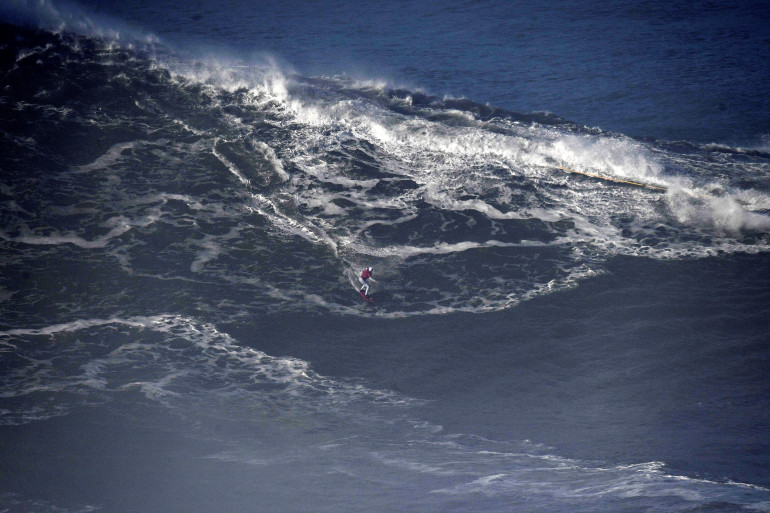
[73, 0, 770, 147]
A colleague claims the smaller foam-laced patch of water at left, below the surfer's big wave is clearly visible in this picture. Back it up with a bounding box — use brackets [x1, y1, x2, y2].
[0, 315, 419, 425]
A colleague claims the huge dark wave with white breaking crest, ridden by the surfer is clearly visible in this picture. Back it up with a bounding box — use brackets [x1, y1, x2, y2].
[0, 16, 770, 317]
